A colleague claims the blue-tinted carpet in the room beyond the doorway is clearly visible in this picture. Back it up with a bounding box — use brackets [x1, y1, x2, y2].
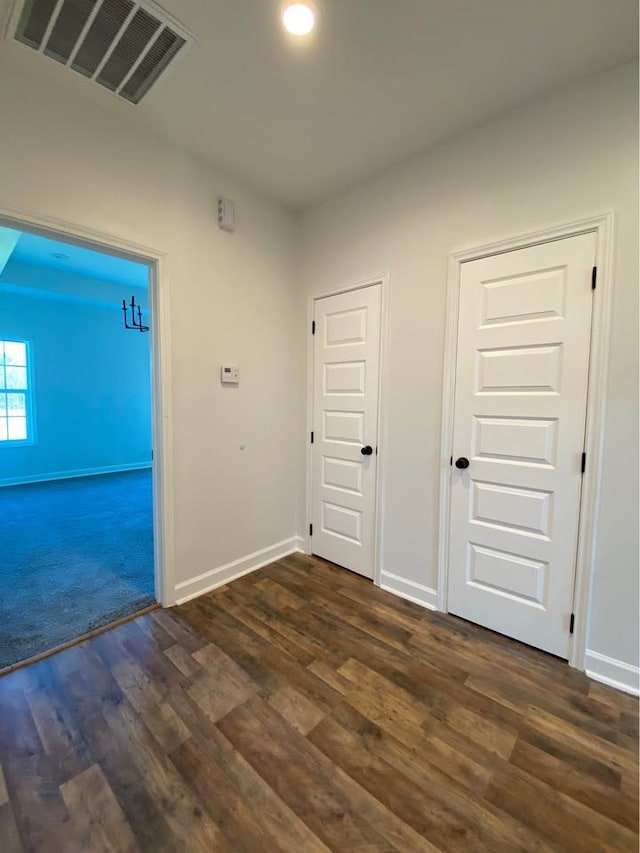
[0, 470, 155, 668]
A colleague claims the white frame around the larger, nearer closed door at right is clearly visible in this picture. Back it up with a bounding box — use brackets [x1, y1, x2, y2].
[437, 211, 614, 670]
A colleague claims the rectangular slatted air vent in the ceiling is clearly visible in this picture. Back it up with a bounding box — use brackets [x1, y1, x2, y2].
[14, 0, 193, 104]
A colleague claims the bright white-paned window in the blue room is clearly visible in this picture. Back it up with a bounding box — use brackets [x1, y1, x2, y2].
[0, 341, 33, 443]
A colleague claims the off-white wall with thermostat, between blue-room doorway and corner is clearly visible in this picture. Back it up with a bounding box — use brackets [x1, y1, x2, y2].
[0, 43, 303, 596]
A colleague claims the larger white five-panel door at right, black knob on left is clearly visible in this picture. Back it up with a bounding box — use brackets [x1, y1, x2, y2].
[448, 234, 596, 658]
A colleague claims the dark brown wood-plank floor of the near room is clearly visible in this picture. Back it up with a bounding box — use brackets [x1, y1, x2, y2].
[0, 555, 638, 853]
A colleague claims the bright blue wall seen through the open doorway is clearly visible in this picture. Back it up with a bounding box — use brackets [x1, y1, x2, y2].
[0, 262, 151, 485]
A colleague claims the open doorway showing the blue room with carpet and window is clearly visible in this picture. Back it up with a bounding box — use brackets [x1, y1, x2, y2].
[0, 222, 161, 670]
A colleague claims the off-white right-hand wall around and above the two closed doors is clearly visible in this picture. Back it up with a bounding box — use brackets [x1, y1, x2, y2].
[301, 67, 638, 678]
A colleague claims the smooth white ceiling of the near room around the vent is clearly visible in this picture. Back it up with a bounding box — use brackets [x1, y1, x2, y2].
[0, 0, 638, 209]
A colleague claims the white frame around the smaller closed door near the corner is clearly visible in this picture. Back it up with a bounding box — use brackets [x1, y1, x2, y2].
[303, 273, 391, 586]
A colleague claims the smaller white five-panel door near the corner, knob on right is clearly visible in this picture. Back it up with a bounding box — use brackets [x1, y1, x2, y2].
[311, 284, 381, 578]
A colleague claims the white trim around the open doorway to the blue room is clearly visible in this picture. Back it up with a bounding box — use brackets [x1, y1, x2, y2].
[0, 207, 175, 607]
